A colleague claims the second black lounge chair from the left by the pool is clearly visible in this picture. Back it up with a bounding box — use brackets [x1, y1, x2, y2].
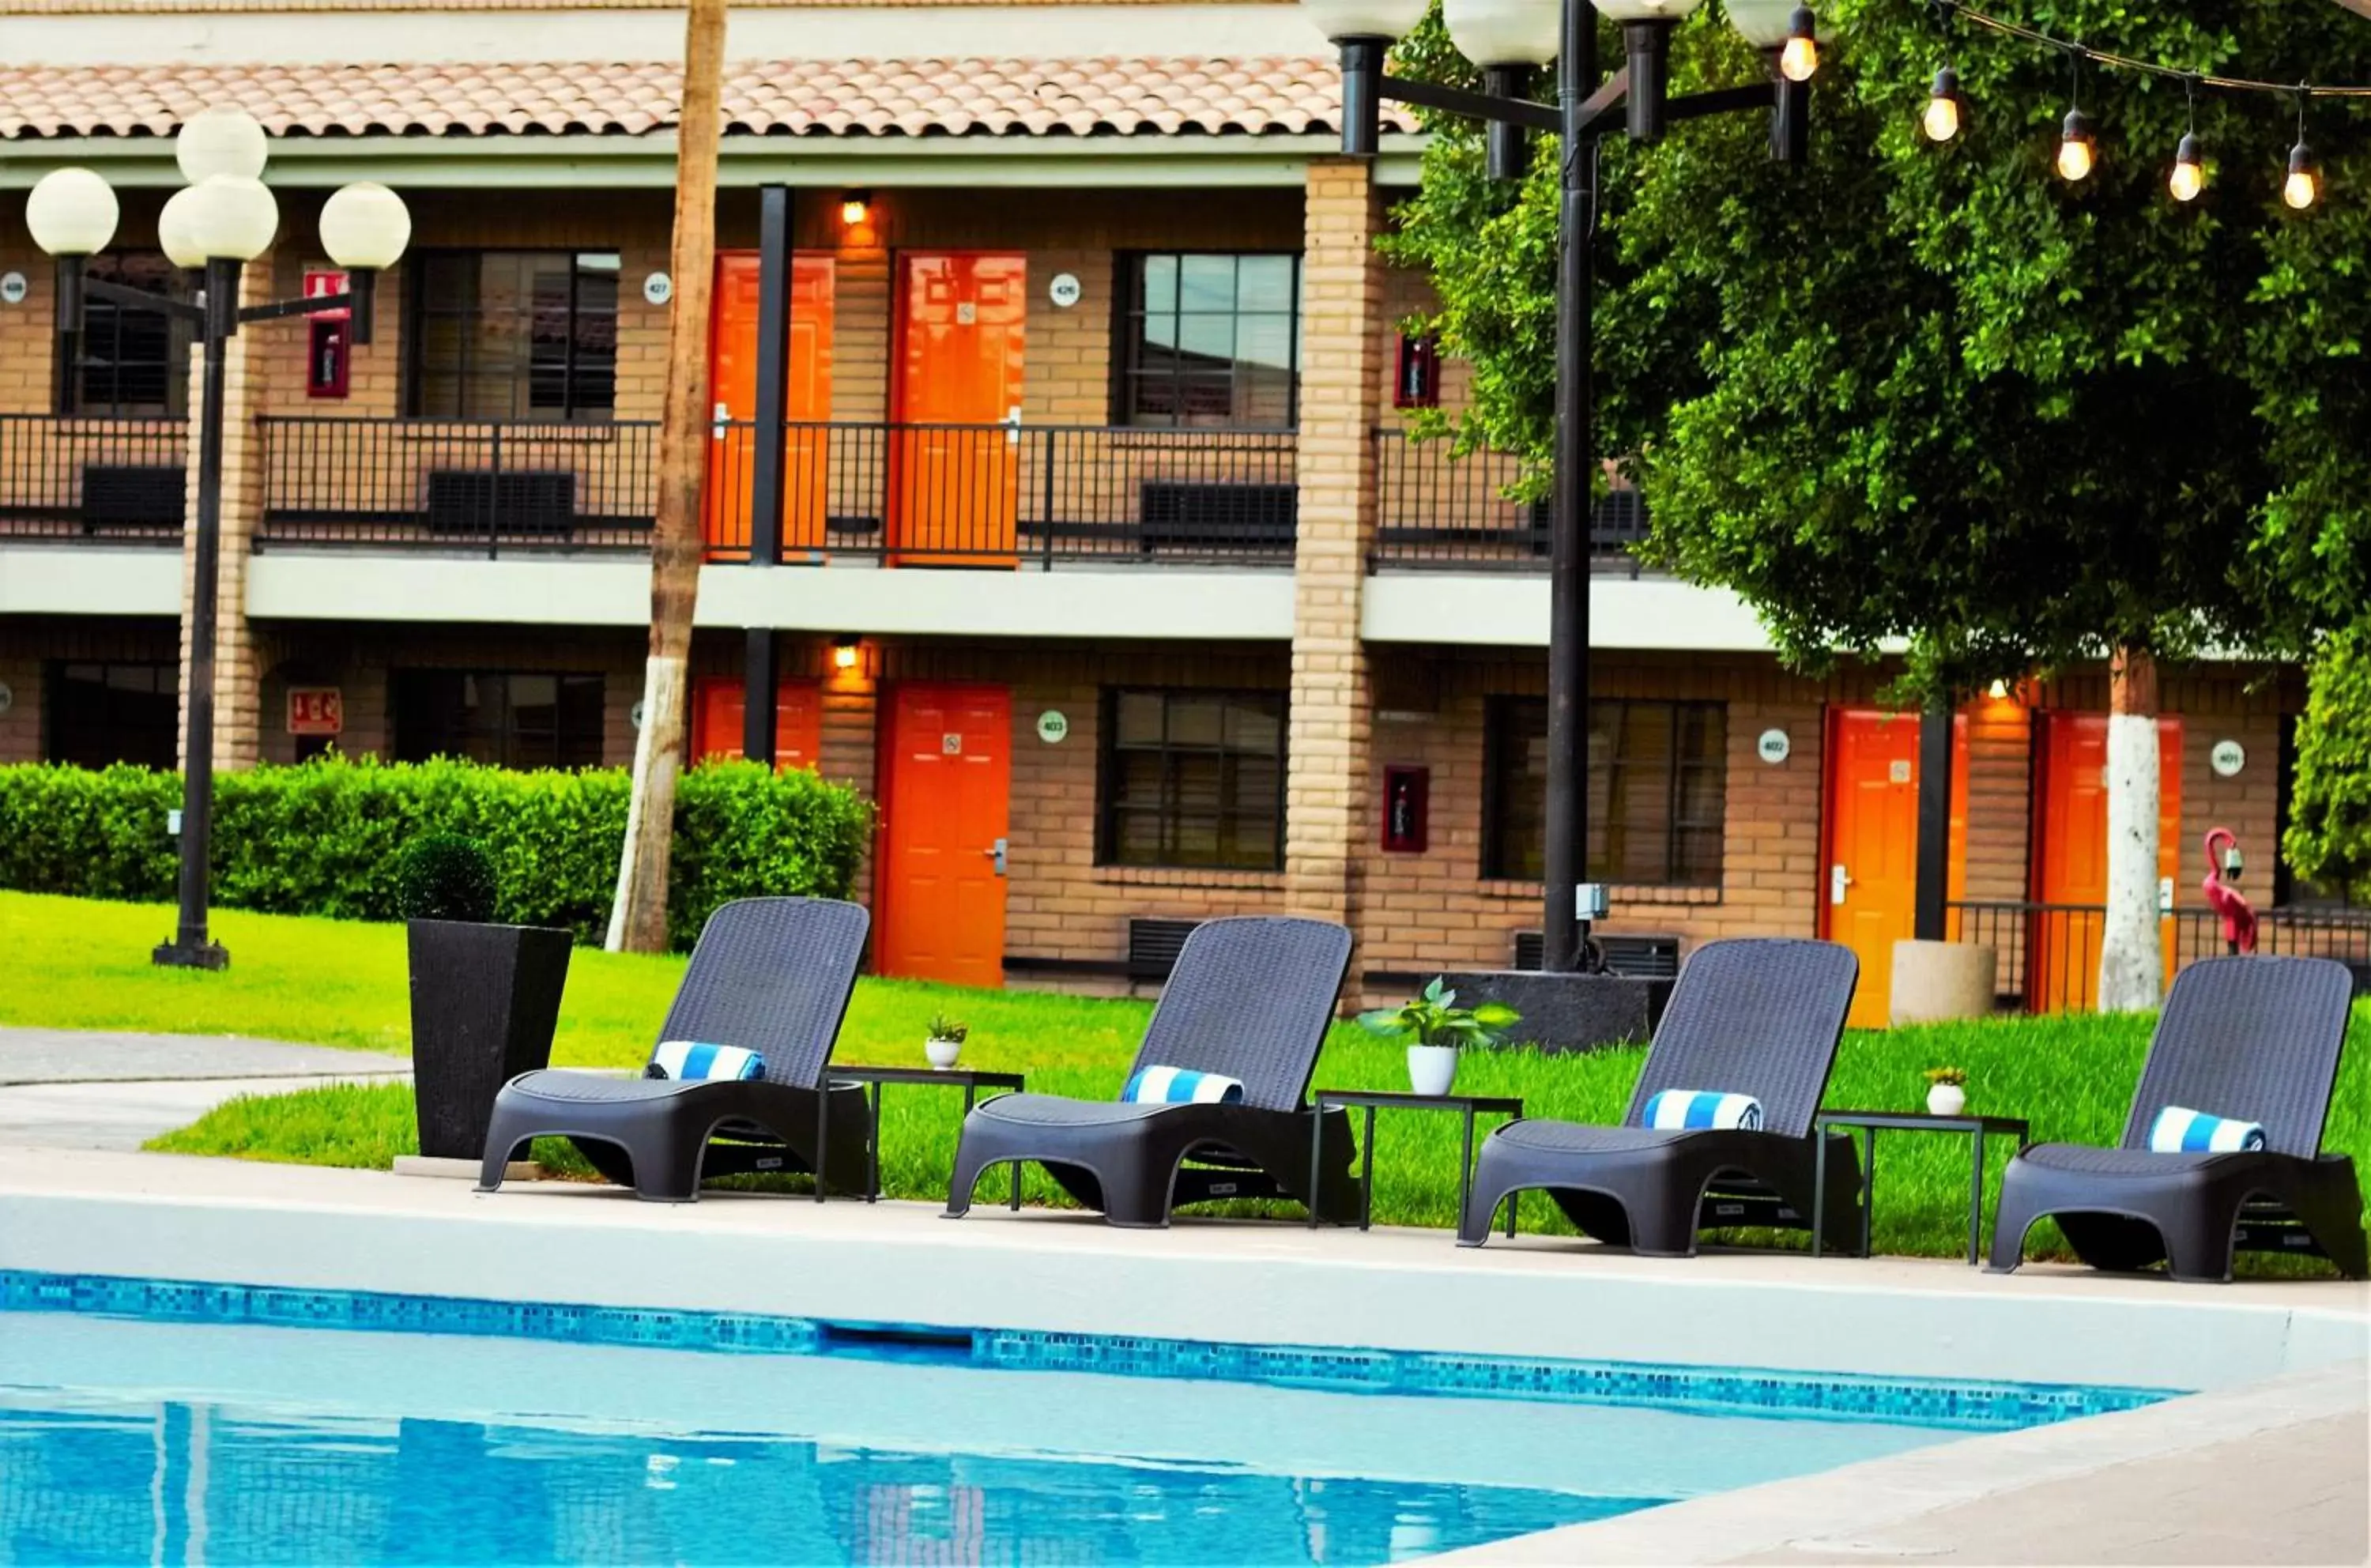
[946, 916, 1359, 1227]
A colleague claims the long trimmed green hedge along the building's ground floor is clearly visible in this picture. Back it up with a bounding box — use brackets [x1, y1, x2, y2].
[0, 756, 873, 949]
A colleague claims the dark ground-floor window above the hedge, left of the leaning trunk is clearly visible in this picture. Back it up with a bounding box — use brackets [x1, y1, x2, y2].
[394, 669, 602, 768]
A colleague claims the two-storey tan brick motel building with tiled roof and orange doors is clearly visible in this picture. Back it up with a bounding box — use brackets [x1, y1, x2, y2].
[0, 0, 2364, 1020]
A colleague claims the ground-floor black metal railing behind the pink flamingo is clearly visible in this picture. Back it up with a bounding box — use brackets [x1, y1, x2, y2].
[1949, 899, 2371, 1013]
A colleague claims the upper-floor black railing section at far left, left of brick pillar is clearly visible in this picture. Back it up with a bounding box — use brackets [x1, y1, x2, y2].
[0, 413, 190, 545]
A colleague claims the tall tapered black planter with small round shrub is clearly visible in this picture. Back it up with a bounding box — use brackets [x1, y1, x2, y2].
[396, 833, 571, 1165]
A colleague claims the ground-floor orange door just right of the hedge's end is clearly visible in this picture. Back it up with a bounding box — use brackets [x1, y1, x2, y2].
[873, 685, 1012, 987]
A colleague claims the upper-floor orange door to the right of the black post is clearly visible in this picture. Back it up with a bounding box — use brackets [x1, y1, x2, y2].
[889, 254, 1029, 567]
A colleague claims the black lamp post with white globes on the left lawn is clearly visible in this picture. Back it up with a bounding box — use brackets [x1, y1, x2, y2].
[24, 109, 413, 971]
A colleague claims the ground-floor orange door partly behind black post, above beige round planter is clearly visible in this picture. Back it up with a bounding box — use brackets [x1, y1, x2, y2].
[1819, 709, 1968, 1030]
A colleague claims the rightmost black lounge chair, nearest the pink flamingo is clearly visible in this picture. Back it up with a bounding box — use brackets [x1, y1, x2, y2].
[1992, 956, 2371, 1281]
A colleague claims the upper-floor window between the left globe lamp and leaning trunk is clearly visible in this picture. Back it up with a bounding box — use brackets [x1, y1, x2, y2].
[405, 251, 619, 420]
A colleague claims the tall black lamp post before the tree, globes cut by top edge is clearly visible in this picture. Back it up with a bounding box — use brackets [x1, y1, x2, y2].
[1302, 0, 1819, 973]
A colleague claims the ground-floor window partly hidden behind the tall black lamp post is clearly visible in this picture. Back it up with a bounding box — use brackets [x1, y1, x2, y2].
[1482, 697, 1728, 888]
